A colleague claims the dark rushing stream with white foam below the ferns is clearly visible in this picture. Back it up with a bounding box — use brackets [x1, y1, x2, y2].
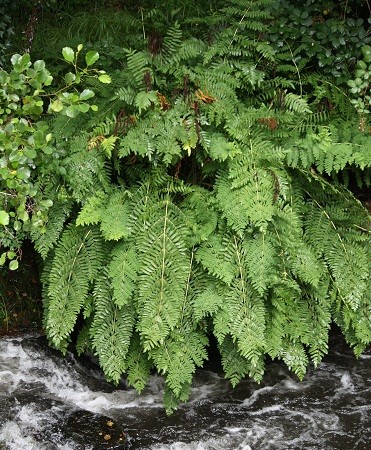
[0, 330, 371, 450]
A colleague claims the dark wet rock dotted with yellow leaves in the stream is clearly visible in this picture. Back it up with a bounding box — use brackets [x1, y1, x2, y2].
[62, 411, 129, 450]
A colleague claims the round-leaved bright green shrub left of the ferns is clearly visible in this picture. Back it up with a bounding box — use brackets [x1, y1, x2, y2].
[0, 45, 110, 270]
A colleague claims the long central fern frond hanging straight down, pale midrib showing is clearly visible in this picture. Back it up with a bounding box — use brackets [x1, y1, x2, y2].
[137, 196, 188, 351]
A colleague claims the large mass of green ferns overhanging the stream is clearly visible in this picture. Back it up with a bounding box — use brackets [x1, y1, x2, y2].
[2, 0, 371, 412]
